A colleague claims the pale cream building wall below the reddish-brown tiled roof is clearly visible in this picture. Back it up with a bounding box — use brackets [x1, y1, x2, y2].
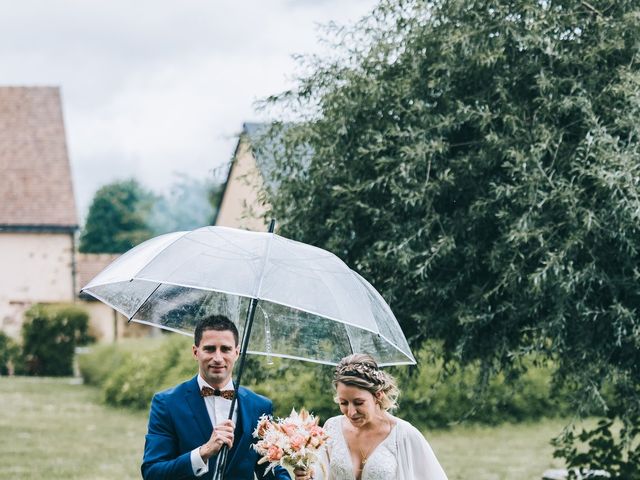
[0, 232, 74, 337]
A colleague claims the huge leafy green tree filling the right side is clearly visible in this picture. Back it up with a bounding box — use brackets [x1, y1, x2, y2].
[267, 0, 640, 472]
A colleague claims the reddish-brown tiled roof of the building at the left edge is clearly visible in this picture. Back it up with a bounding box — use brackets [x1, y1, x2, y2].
[0, 87, 78, 228]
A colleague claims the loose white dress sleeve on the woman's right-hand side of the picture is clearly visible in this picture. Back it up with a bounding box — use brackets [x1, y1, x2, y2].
[397, 419, 448, 480]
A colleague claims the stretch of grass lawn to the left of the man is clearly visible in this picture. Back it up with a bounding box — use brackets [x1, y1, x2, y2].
[0, 377, 147, 480]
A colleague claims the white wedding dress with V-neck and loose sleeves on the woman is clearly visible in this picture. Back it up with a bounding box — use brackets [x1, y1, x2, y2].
[314, 415, 447, 480]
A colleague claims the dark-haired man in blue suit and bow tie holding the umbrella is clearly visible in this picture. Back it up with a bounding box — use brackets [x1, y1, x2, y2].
[142, 315, 290, 480]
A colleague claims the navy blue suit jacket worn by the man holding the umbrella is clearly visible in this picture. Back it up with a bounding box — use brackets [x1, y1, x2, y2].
[142, 376, 290, 480]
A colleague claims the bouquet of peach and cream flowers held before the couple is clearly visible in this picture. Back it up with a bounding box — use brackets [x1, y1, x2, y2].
[253, 408, 328, 475]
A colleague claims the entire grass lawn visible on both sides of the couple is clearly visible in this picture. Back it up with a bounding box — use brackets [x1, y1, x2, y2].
[0, 377, 564, 480]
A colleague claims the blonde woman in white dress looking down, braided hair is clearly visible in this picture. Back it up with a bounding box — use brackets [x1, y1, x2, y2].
[295, 354, 447, 480]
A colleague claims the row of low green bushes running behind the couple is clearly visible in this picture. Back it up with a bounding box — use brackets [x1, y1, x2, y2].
[79, 335, 570, 428]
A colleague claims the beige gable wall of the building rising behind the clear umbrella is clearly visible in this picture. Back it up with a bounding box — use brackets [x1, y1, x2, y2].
[216, 139, 267, 232]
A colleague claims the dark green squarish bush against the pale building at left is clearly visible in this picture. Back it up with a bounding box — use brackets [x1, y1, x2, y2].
[22, 304, 93, 376]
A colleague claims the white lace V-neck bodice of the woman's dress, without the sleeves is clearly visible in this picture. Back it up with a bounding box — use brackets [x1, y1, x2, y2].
[325, 417, 398, 480]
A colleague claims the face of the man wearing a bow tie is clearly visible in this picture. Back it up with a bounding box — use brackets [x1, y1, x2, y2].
[193, 330, 240, 388]
